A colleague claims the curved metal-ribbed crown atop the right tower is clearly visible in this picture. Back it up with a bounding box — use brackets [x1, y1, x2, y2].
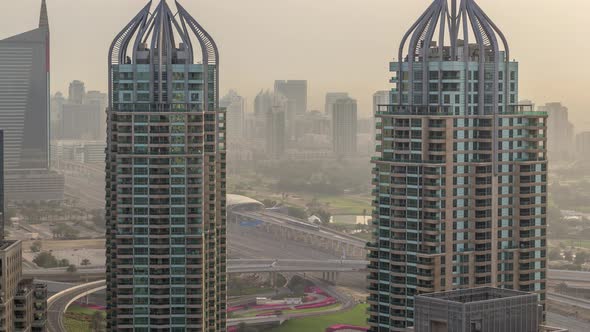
[399, 0, 509, 62]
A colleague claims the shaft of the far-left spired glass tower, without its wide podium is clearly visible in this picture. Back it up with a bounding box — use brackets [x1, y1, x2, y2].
[0, 0, 50, 170]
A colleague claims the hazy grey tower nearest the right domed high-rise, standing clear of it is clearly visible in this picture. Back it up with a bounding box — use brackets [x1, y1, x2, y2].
[332, 98, 358, 155]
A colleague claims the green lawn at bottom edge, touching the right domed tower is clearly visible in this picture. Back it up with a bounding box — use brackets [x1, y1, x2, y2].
[269, 304, 368, 332]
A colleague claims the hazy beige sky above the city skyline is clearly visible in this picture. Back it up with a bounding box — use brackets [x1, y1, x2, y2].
[0, 0, 590, 130]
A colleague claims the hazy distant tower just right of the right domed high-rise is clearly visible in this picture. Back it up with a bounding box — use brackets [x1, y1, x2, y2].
[538, 103, 575, 162]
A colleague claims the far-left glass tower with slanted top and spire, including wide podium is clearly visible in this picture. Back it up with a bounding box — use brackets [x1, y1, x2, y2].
[0, 0, 64, 201]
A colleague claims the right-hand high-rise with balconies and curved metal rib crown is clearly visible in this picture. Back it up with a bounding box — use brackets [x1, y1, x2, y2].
[368, 0, 547, 331]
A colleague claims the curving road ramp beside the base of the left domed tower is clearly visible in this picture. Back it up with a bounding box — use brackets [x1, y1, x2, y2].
[47, 280, 106, 332]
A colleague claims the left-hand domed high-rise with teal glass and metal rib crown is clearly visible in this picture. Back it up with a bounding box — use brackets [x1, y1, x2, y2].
[106, 0, 227, 332]
